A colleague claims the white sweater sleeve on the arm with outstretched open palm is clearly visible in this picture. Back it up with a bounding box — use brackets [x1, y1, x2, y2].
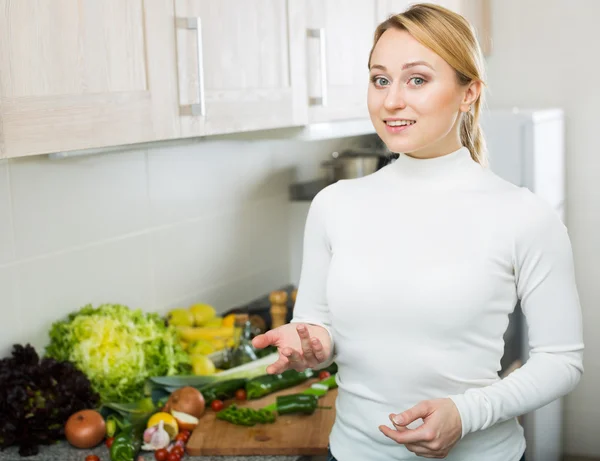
[292, 186, 335, 368]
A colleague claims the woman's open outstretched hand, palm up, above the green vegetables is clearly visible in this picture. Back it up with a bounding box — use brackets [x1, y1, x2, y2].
[252, 323, 332, 374]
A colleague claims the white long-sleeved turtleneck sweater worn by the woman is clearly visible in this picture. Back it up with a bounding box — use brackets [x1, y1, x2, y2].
[293, 147, 583, 461]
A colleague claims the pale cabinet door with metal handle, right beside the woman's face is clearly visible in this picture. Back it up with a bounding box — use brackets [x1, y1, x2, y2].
[306, 0, 376, 122]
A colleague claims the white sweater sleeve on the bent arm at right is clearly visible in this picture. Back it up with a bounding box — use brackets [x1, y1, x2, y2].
[450, 192, 584, 437]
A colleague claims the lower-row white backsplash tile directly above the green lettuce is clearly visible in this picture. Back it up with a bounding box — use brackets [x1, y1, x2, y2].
[15, 235, 152, 347]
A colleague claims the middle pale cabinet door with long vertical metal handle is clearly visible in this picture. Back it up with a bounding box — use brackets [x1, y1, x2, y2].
[175, 0, 307, 136]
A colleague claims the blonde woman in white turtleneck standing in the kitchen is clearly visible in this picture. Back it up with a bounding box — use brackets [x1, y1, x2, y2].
[254, 4, 583, 461]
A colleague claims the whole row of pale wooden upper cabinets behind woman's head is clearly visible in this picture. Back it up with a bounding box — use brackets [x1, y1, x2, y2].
[0, 0, 489, 158]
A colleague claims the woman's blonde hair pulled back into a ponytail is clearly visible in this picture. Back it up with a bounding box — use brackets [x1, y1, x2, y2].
[369, 3, 487, 165]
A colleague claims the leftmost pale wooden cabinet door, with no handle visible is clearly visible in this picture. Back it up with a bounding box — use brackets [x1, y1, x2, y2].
[0, 0, 179, 157]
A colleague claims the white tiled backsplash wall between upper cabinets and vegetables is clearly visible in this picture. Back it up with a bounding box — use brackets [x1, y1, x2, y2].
[0, 133, 360, 357]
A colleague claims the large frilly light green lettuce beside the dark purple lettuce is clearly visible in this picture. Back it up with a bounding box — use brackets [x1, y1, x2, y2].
[45, 304, 191, 403]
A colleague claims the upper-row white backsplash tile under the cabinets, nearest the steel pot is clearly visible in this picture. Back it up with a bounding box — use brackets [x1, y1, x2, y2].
[148, 141, 290, 225]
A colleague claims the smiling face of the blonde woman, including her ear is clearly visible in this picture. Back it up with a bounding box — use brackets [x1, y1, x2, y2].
[367, 29, 480, 158]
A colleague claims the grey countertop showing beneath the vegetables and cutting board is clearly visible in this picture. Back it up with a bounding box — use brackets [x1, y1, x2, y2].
[0, 442, 310, 461]
